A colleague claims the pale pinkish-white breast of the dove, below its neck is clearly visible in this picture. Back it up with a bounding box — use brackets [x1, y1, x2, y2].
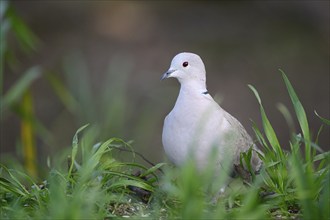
[162, 97, 228, 166]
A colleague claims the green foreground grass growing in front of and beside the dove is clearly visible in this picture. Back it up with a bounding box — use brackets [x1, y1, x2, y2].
[0, 73, 330, 219]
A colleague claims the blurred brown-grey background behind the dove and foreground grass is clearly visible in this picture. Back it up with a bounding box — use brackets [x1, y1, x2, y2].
[0, 0, 329, 175]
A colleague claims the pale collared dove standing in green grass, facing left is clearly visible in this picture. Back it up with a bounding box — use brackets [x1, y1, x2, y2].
[161, 52, 262, 183]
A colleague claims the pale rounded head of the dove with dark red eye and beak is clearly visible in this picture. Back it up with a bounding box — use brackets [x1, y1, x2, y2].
[161, 52, 206, 84]
